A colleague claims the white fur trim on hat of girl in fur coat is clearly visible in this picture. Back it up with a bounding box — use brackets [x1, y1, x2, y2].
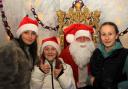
[16, 24, 38, 38]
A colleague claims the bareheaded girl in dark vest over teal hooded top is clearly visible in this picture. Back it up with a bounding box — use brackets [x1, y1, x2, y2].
[90, 22, 128, 89]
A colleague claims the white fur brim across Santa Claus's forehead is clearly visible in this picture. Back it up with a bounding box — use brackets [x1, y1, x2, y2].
[75, 30, 91, 39]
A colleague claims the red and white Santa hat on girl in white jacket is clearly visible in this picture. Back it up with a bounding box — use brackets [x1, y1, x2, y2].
[40, 36, 60, 55]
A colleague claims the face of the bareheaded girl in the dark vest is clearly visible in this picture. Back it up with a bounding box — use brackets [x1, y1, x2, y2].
[100, 25, 118, 48]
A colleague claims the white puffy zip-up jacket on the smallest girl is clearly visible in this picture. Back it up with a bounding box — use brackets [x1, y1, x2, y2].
[31, 59, 76, 89]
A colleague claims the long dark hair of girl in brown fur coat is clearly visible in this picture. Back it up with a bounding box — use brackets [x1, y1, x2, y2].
[16, 36, 38, 66]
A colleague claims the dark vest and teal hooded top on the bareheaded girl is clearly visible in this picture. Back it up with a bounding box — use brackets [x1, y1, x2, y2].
[90, 42, 128, 89]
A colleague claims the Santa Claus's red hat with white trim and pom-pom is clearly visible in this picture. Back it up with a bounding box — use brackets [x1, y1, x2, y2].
[64, 23, 94, 43]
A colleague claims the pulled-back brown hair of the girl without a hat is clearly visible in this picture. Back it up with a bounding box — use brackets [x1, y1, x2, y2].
[99, 22, 121, 43]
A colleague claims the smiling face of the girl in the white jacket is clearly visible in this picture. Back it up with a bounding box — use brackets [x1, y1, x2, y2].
[44, 45, 57, 61]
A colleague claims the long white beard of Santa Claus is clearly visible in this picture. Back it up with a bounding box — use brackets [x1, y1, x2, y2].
[69, 41, 95, 68]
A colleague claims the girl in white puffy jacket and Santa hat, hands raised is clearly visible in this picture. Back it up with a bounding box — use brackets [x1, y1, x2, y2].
[31, 37, 76, 89]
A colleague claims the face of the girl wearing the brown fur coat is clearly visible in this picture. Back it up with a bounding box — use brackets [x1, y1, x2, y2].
[21, 30, 37, 45]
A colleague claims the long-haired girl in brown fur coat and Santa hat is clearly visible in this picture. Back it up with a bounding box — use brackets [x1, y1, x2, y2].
[0, 16, 38, 89]
